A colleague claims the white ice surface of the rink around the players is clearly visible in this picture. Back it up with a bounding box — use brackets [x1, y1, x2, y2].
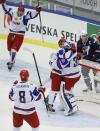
[0, 40, 100, 131]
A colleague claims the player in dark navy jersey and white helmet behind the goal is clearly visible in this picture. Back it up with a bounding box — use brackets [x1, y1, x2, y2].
[77, 30, 97, 92]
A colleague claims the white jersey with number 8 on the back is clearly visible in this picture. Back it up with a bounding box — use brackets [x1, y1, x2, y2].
[9, 82, 41, 114]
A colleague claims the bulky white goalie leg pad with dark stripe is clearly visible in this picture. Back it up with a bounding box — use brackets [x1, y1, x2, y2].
[60, 86, 78, 115]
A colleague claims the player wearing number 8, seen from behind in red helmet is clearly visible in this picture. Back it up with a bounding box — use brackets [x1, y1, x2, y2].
[9, 70, 45, 131]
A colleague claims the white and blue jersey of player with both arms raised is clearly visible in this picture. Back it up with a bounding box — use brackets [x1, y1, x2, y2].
[2, 4, 38, 35]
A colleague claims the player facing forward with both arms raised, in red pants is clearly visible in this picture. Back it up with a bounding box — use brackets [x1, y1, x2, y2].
[2, 0, 41, 70]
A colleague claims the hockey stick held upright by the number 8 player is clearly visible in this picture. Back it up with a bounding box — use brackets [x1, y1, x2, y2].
[24, 48, 48, 112]
